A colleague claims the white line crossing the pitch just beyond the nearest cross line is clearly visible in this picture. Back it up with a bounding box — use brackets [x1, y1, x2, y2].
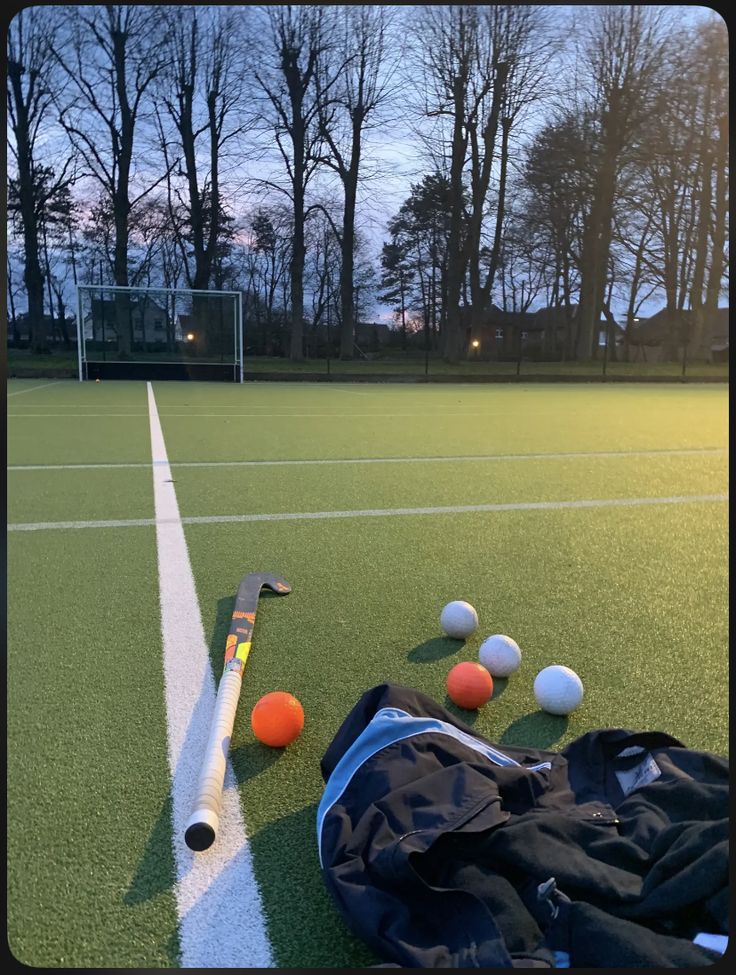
[7, 447, 728, 471]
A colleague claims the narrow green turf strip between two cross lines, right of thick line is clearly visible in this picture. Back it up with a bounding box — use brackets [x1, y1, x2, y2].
[170, 454, 728, 530]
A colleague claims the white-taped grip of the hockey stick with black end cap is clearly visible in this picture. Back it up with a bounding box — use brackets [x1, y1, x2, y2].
[184, 661, 243, 851]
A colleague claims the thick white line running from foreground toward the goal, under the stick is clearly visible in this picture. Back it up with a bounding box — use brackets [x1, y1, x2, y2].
[147, 383, 274, 968]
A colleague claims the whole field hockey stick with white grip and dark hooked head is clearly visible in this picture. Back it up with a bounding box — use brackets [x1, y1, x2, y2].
[184, 572, 291, 850]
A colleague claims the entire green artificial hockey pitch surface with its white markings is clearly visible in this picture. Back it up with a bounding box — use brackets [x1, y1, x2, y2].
[7, 380, 728, 968]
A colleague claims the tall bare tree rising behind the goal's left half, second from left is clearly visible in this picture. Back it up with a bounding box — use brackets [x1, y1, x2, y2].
[54, 4, 172, 353]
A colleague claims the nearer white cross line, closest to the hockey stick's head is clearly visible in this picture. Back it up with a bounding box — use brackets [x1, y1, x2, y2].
[8, 496, 728, 531]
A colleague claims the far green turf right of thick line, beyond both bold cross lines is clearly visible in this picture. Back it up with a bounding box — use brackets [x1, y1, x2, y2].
[156, 384, 728, 462]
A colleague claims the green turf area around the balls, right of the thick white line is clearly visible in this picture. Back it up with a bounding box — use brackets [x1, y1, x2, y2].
[187, 504, 728, 967]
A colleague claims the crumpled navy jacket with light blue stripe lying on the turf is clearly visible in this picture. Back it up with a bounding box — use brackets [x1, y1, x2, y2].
[317, 684, 728, 968]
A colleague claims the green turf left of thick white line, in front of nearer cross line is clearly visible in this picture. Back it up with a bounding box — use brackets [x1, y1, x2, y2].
[7, 528, 178, 969]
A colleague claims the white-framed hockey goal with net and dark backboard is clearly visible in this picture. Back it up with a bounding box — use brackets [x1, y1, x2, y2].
[77, 284, 243, 383]
